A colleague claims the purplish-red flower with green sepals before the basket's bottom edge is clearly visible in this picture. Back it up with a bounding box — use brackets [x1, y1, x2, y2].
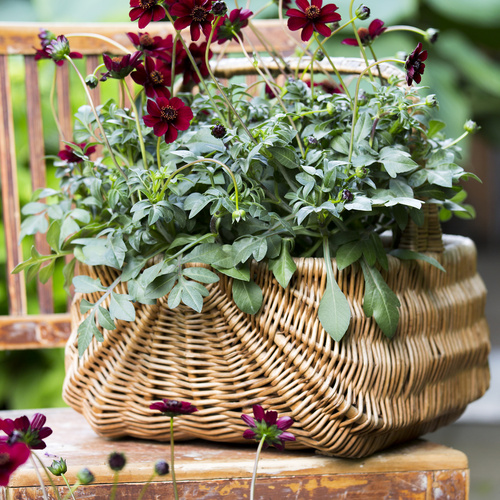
[241, 405, 295, 450]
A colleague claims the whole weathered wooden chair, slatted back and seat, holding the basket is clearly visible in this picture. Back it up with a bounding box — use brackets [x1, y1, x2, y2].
[0, 21, 469, 500]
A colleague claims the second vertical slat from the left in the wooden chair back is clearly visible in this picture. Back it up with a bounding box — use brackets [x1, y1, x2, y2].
[24, 56, 54, 314]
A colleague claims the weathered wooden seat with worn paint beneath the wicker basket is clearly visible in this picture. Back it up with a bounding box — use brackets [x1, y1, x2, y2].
[0, 408, 469, 500]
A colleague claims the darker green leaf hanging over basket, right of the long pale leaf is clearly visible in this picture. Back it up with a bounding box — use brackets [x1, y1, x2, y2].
[360, 260, 401, 338]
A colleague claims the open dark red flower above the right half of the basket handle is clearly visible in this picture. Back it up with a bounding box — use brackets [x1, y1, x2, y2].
[286, 0, 341, 42]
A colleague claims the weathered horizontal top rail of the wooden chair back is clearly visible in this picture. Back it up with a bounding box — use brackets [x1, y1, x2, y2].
[0, 19, 297, 55]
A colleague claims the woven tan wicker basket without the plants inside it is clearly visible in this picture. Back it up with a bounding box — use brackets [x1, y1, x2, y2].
[63, 59, 490, 457]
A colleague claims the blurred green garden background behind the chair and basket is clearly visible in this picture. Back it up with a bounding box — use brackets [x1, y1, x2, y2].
[0, 0, 500, 409]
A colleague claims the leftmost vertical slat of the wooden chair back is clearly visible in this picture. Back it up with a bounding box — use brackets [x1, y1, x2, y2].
[0, 55, 27, 315]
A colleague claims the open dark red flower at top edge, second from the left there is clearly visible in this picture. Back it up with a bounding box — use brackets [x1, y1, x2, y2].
[170, 0, 214, 42]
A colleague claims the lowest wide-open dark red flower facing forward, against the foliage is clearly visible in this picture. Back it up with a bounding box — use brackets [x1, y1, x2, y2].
[143, 97, 194, 143]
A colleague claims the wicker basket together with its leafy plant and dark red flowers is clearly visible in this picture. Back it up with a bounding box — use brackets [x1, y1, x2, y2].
[15, 0, 488, 456]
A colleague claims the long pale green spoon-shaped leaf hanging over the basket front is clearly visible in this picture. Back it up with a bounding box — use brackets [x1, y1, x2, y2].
[318, 238, 351, 342]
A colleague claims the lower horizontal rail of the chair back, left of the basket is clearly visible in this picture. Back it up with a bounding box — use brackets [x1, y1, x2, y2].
[0, 314, 71, 350]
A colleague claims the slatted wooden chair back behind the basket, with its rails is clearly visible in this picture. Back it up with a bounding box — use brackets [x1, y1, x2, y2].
[0, 20, 295, 350]
